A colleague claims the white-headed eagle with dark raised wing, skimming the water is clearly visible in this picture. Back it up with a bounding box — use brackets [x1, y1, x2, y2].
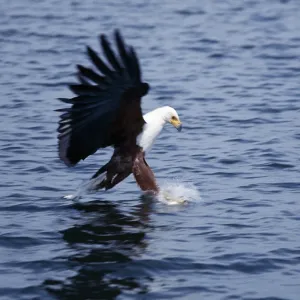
[57, 30, 182, 193]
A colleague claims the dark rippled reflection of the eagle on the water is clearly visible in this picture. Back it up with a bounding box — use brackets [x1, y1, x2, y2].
[44, 197, 152, 299]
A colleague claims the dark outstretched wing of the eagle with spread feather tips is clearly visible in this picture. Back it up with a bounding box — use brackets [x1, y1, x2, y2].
[58, 31, 149, 166]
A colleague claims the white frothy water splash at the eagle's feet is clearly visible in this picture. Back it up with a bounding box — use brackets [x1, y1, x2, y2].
[157, 180, 201, 205]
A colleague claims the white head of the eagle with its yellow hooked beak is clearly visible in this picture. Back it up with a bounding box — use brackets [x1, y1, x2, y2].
[144, 106, 182, 131]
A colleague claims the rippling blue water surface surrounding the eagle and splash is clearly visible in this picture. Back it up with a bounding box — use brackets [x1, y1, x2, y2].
[0, 0, 300, 300]
